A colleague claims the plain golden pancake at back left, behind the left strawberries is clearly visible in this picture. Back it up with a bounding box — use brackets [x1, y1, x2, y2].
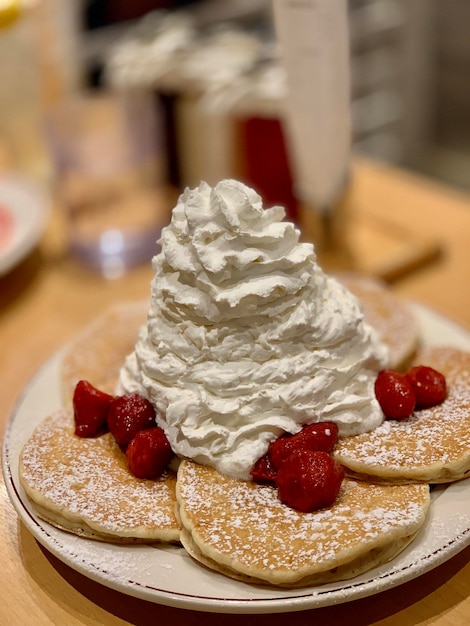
[61, 300, 148, 404]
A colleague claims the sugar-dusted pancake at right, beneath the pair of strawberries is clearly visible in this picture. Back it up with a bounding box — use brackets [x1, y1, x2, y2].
[335, 347, 470, 483]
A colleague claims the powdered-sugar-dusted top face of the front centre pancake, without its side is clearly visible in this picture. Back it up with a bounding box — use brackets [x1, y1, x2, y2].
[178, 456, 428, 571]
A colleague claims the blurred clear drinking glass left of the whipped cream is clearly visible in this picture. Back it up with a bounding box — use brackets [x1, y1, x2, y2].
[48, 91, 166, 278]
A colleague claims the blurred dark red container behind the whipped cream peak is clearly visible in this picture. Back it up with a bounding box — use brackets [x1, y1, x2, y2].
[238, 117, 297, 221]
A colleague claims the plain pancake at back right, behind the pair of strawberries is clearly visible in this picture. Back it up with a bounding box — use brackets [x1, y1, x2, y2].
[336, 272, 420, 371]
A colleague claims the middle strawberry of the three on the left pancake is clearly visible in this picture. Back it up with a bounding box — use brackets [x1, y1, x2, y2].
[108, 393, 156, 447]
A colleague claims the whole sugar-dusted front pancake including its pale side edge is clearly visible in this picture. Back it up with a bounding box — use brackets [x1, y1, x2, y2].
[176, 461, 429, 587]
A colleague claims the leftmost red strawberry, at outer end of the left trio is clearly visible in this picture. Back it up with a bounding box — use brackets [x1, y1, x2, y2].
[72, 380, 113, 437]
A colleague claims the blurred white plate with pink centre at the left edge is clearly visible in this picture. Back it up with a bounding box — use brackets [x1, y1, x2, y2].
[0, 176, 49, 276]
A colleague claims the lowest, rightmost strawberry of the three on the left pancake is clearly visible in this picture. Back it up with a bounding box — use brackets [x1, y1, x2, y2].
[126, 426, 173, 479]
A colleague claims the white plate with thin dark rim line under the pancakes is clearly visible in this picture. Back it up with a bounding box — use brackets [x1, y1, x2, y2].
[3, 305, 470, 613]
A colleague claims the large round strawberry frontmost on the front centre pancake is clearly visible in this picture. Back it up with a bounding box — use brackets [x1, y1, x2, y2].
[276, 450, 344, 513]
